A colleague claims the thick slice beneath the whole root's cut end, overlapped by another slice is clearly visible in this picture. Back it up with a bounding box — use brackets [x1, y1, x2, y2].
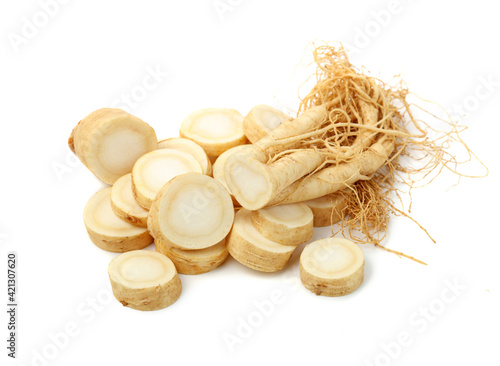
[228, 209, 296, 272]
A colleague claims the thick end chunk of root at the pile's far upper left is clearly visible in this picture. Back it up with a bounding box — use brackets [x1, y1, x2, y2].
[68, 108, 158, 184]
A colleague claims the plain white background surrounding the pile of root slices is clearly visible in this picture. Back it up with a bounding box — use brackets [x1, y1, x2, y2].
[0, 0, 500, 366]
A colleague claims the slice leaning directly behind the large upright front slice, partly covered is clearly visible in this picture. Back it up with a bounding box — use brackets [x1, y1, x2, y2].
[132, 149, 202, 209]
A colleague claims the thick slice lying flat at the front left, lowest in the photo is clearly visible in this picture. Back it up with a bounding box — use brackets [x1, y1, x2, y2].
[108, 251, 182, 311]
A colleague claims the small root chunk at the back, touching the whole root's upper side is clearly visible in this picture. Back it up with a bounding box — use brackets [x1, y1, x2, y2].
[243, 104, 292, 144]
